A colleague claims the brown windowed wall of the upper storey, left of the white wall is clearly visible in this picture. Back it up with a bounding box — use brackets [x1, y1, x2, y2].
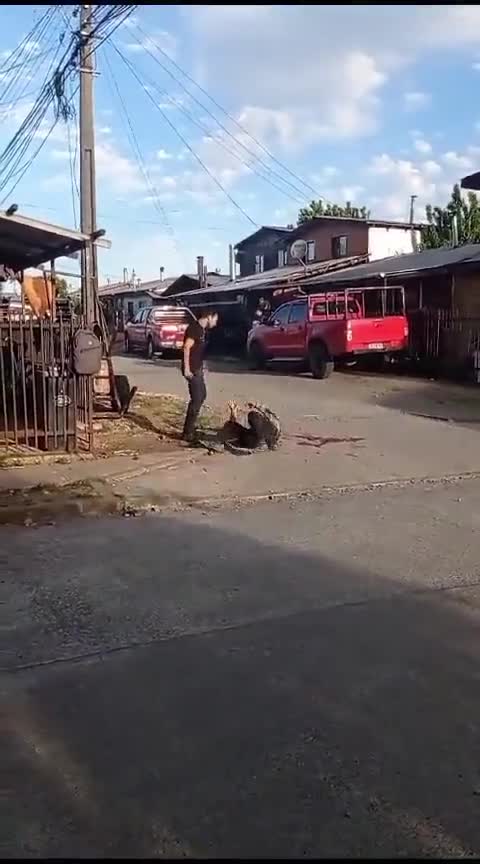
[275, 219, 368, 266]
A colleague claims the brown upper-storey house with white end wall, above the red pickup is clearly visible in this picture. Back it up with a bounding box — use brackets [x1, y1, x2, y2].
[276, 216, 421, 267]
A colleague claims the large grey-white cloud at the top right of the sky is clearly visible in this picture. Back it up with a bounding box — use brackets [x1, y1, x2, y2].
[182, 4, 480, 152]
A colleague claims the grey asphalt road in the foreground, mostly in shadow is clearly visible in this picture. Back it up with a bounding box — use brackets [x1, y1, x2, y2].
[0, 481, 480, 857]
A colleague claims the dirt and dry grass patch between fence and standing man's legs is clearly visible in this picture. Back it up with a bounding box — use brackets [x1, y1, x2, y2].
[95, 393, 221, 457]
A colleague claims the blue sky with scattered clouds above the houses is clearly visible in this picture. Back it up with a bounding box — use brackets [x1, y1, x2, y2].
[0, 4, 480, 281]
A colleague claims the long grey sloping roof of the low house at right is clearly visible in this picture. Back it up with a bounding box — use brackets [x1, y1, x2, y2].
[309, 243, 480, 284]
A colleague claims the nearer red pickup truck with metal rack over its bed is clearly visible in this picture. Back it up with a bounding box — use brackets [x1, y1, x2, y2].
[247, 287, 408, 378]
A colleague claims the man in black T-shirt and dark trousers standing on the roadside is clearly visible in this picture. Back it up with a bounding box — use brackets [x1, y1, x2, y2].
[182, 310, 218, 442]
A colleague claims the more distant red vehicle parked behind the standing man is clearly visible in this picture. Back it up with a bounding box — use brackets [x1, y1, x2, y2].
[125, 306, 194, 359]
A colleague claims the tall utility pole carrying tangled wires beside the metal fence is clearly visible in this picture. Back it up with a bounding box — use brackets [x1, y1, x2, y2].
[80, 3, 98, 324]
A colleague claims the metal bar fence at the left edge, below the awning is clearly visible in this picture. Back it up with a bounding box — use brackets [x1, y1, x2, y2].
[0, 310, 93, 451]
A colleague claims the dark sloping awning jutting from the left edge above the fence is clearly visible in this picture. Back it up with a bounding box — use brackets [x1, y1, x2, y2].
[0, 213, 110, 271]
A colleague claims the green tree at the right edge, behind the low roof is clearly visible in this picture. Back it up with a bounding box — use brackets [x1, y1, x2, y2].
[422, 183, 480, 249]
